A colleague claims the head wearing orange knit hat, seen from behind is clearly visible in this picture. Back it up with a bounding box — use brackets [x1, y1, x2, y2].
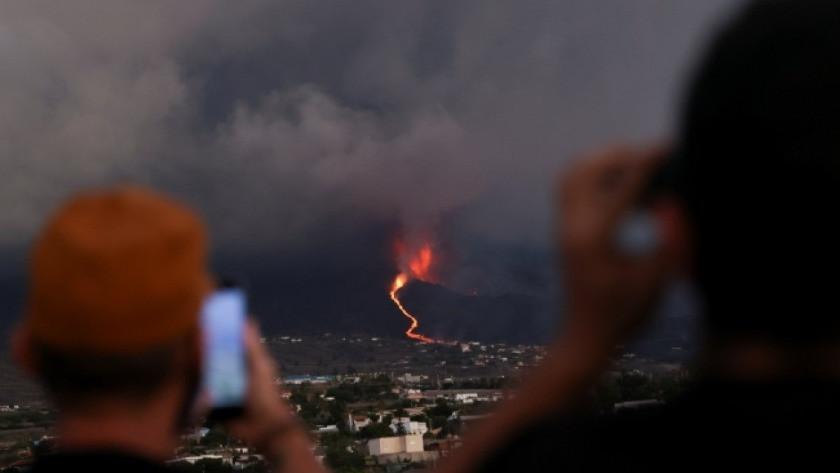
[18, 187, 210, 408]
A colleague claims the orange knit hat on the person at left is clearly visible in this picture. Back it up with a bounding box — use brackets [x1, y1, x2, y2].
[24, 187, 211, 354]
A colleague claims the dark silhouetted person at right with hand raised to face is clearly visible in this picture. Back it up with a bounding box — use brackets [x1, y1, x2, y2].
[441, 0, 840, 472]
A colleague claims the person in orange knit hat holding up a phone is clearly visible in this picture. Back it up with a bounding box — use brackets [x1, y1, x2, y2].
[12, 187, 321, 473]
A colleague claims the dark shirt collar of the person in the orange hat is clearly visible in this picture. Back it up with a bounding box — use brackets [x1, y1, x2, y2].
[31, 451, 172, 473]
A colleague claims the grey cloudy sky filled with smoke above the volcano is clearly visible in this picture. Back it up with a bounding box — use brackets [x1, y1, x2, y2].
[0, 0, 742, 340]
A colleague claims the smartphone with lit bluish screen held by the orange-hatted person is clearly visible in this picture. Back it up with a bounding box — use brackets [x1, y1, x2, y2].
[201, 286, 248, 419]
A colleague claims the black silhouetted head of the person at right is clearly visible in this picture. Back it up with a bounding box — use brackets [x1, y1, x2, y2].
[673, 0, 840, 343]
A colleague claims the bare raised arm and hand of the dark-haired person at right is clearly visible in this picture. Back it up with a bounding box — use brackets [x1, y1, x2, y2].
[437, 147, 667, 473]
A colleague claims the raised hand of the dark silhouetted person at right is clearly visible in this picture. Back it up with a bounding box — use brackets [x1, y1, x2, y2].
[558, 146, 667, 342]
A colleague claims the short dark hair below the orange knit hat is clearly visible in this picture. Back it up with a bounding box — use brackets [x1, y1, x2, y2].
[33, 343, 185, 409]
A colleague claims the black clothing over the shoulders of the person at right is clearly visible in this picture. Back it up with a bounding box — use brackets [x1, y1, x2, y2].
[479, 381, 840, 473]
